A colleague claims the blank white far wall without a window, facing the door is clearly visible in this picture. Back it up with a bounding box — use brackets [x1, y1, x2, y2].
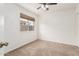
[39, 9, 77, 45]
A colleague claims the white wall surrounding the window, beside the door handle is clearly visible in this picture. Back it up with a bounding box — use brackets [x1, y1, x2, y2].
[5, 3, 38, 52]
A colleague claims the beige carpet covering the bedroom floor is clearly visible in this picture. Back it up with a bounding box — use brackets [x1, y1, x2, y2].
[5, 40, 79, 56]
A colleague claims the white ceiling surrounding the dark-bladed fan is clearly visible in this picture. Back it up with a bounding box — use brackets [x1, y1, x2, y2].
[19, 3, 77, 15]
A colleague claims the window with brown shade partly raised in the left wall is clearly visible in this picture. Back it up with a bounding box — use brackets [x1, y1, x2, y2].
[20, 14, 35, 31]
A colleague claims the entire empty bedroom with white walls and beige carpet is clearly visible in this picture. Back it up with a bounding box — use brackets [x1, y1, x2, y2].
[0, 3, 79, 56]
